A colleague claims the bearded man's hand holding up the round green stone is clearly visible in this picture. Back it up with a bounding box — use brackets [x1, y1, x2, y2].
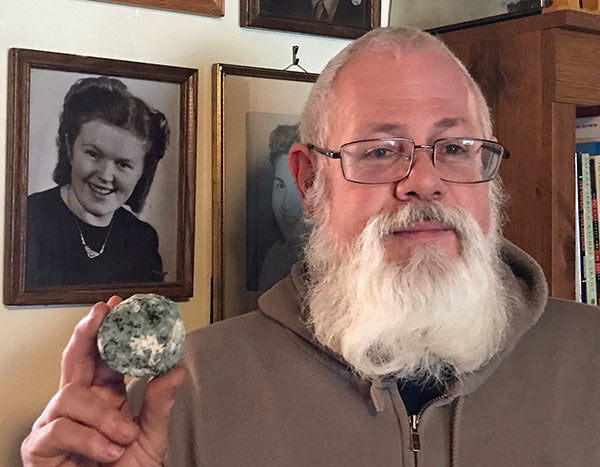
[21, 297, 185, 467]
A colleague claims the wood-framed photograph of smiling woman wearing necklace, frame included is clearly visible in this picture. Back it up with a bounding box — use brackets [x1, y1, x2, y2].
[4, 49, 198, 305]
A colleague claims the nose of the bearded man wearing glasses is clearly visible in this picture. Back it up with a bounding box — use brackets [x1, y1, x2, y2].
[396, 148, 447, 201]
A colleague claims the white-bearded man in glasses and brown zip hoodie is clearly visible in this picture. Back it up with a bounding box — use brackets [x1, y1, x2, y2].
[22, 28, 600, 467]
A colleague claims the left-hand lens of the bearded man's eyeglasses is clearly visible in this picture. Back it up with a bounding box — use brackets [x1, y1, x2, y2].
[340, 138, 414, 183]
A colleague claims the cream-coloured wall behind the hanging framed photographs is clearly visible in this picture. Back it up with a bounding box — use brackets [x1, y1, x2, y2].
[0, 0, 389, 466]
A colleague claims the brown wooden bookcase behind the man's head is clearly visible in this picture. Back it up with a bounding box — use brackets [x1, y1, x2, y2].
[440, 10, 600, 298]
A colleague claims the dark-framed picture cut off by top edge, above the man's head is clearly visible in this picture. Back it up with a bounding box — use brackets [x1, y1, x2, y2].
[240, 0, 381, 39]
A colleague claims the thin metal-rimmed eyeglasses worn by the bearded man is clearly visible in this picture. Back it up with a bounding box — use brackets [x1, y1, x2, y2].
[307, 138, 510, 184]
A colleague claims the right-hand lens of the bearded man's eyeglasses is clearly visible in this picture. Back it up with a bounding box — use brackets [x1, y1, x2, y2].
[434, 138, 504, 183]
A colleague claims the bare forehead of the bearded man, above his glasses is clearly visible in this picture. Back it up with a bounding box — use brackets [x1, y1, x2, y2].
[332, 49, 480, 143]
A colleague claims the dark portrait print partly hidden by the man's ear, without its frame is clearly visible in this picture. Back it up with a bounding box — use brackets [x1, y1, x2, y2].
[246, 112, 307, 291]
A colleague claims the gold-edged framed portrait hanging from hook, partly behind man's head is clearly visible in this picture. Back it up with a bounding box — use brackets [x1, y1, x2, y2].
[211, 64, 318, 321]
